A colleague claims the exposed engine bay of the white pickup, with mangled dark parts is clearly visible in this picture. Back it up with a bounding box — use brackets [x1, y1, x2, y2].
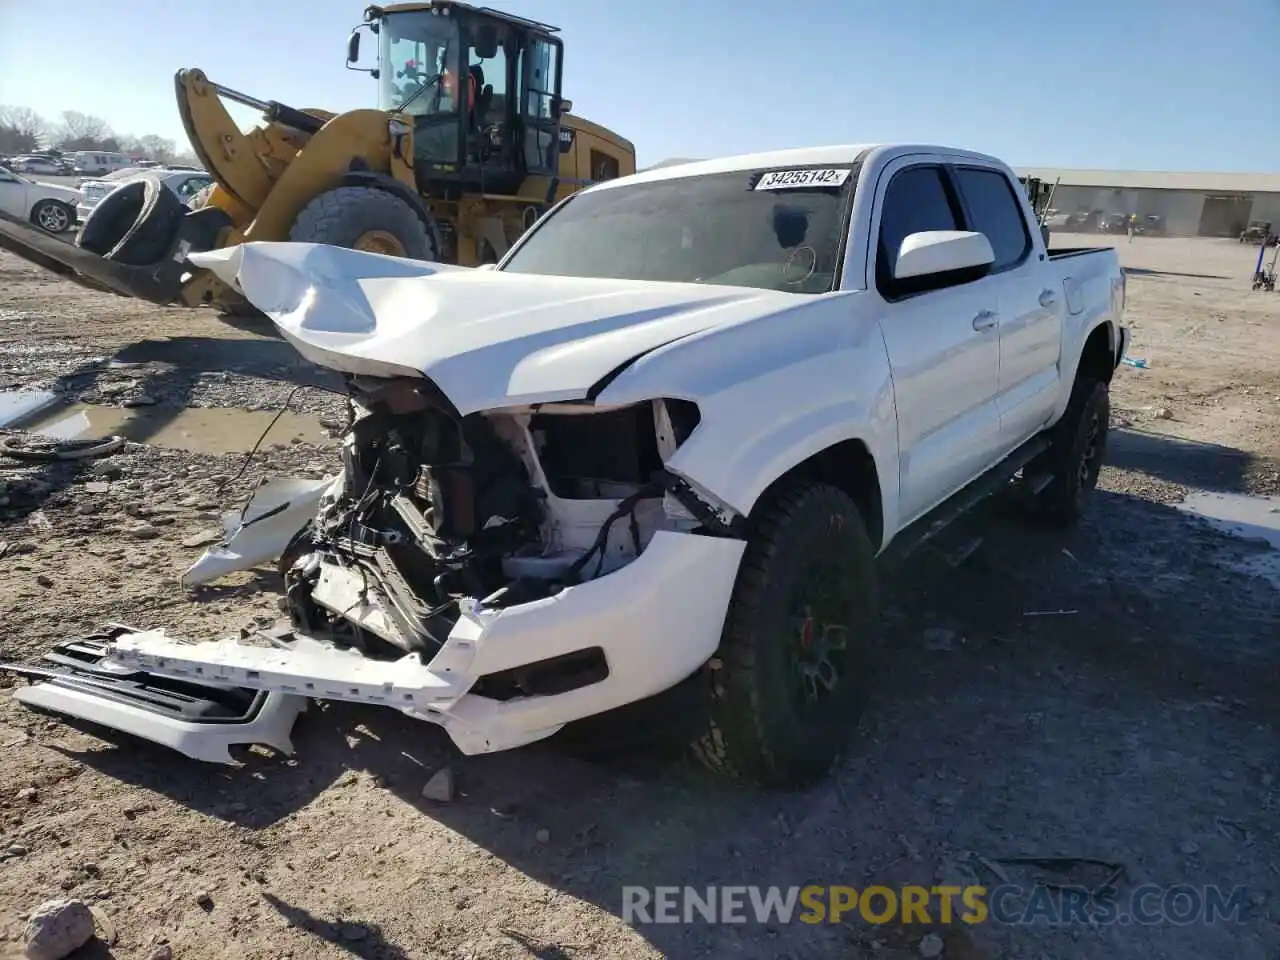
[282, 376, 731, 699]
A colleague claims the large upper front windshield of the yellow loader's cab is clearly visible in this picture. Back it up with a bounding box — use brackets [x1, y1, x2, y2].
[378, 10, 458, 116]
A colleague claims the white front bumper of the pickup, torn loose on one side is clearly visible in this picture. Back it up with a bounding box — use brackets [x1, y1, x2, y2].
[10, 531, 745, 759]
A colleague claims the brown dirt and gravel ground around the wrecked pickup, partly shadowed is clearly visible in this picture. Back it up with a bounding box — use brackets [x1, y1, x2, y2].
[0, 237, 1280, 960]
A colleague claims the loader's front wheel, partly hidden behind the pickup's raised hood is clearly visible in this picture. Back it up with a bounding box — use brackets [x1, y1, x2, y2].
[289, 187, 440, 261]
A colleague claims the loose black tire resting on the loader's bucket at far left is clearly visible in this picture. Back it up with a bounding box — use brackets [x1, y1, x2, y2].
[76, 175, 187, 266]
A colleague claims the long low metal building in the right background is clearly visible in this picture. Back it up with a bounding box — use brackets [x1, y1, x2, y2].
[1018, 166, 1280, 237]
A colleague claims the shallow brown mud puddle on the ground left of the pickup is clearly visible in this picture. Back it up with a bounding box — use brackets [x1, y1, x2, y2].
[13, 403, 334, 454]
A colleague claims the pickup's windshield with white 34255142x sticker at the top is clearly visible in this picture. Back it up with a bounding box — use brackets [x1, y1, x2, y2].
[502, 166, 856, 293]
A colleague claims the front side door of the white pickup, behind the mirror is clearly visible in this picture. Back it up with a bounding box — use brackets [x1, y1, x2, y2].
[868, 157, 1000, 524]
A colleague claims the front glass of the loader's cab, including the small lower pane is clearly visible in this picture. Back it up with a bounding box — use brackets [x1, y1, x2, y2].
[379, 10, 468, 164]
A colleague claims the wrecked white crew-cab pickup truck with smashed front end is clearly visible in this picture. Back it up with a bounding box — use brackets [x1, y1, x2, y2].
[5, 145, 1128, 785]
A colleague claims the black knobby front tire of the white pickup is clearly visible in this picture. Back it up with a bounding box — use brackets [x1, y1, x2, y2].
[694, 481, 878, 788]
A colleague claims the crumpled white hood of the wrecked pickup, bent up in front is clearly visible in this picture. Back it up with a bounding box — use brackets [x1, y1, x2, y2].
[189, 242, 795, 416]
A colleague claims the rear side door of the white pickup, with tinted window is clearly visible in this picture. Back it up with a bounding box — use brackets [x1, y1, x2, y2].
[952, 165, 1065, 451]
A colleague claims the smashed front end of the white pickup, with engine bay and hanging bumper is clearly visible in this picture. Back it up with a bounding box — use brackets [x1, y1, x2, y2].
[2, 241, 745, 762]
